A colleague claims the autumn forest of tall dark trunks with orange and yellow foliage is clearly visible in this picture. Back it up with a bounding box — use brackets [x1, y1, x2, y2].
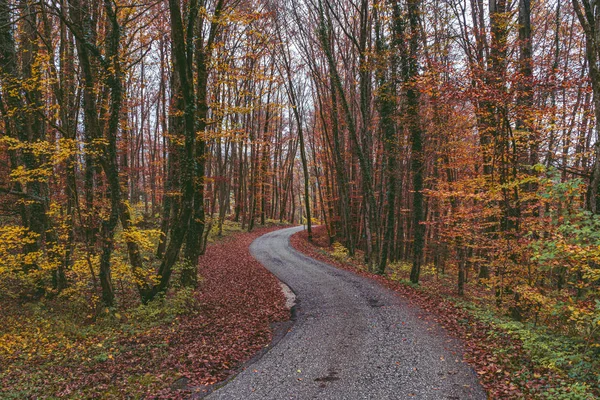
[0, 0, 600, 399]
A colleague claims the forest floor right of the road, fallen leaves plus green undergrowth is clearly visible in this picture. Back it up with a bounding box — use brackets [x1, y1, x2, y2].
[290, 226, 600, 400]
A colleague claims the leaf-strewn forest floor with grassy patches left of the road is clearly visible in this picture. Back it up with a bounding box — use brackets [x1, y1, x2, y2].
[0, 220, 290, 399]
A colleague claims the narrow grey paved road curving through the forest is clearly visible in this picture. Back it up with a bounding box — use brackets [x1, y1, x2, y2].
[208, 227, 486, 400]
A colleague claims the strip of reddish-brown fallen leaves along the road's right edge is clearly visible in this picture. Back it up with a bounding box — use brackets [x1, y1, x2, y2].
[291, 226, 580, 399]
